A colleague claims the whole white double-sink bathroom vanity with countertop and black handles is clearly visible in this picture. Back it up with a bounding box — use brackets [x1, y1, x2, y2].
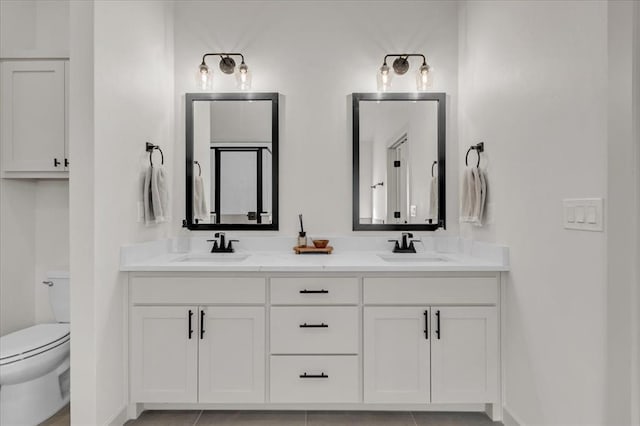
[121, 237, 508, 419]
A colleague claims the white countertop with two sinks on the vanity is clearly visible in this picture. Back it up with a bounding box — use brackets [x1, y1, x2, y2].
[120, 236, 509, 272]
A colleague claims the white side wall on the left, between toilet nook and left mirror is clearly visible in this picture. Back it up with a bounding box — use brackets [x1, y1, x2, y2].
[70, 1, 174, 424]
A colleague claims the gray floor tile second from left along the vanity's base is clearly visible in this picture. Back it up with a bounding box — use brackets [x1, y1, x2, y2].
[197, 411, 305, 426]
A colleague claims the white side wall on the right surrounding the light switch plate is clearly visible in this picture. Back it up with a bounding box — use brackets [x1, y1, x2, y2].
[460, 1, 637, 425]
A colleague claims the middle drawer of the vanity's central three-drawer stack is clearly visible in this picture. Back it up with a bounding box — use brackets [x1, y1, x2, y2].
[271, 306, 360, 354]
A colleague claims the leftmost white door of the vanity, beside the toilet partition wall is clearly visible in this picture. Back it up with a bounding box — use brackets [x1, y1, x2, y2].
[130, 306, 198, 402]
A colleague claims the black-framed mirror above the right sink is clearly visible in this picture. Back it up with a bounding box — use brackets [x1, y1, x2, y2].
[351, 93, 446, 231]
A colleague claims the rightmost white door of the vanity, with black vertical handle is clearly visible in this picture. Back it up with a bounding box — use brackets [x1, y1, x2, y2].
[431, 306, 498, 403]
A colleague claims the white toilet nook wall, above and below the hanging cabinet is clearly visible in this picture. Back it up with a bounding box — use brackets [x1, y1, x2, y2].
[0, 0, 69, 335]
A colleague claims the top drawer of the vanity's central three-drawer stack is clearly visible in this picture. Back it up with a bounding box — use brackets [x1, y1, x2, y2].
[271, 278, 360, 305]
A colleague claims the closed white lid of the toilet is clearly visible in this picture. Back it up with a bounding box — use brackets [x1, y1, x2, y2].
[0, 323, 69, 363]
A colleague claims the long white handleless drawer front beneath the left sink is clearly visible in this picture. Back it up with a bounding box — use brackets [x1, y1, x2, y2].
[131, 277, 266, 305]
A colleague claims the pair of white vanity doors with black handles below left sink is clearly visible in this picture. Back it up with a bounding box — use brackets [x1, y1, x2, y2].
[131, 306, 265, 403]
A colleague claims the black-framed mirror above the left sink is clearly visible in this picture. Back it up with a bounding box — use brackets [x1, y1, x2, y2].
[185, 93, 278, 230]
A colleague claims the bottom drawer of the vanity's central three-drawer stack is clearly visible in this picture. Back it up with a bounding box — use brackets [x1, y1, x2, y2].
[271, 355, 360, 403]
